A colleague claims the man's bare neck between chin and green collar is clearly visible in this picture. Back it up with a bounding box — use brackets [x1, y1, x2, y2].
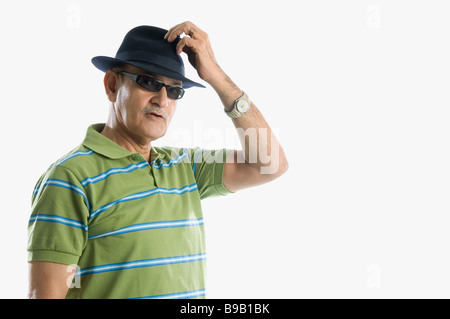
[101, 121, 152, 162]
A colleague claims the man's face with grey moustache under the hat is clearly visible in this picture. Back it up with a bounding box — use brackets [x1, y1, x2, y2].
[114, 65, 182, 141]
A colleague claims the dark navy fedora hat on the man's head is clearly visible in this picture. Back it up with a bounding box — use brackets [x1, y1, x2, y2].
[92, 26, 205, 88]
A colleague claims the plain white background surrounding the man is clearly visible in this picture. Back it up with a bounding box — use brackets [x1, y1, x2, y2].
[0, 0, 450, 298]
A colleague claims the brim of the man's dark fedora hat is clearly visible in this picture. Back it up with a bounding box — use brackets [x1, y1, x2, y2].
[91, 56, 205, 89]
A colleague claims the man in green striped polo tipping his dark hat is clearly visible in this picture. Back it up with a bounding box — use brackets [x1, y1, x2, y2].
[28, 21, 288, 298]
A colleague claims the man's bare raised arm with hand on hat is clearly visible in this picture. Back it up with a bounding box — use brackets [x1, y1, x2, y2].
[165, 21, 289, 192]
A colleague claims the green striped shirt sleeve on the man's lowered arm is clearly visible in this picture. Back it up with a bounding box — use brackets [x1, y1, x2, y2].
[27, 165, 89, 265]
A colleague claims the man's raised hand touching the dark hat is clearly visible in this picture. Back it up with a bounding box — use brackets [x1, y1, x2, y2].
[164, 21, 224, 85]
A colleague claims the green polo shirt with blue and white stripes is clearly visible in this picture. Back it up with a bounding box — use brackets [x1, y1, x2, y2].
[28, 124, 229, 298]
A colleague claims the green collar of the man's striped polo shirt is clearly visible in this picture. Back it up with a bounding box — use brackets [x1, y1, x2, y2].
[83, 123, 162, 161]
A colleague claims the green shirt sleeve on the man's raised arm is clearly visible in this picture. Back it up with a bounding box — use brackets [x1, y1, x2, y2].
[189, 148, 231, 199]
